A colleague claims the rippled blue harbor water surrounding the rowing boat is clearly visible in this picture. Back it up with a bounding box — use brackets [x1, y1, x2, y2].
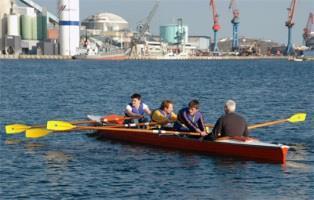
[0, 60, 314, 199]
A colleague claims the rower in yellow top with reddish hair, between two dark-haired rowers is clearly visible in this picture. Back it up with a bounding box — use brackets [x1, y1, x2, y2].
[152, 100, 177, 130]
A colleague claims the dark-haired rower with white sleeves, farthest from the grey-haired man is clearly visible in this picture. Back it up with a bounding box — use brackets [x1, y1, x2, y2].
[124, 93, 151, 124]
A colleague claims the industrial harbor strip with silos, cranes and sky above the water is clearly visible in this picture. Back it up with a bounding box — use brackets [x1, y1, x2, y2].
[0, 0, 314, 61]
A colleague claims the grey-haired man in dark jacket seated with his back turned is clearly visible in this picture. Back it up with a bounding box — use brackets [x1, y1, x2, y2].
[210, 100, 249, 140]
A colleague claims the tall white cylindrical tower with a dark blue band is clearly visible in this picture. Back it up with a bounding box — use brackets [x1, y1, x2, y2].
[59, 0, 80, 56]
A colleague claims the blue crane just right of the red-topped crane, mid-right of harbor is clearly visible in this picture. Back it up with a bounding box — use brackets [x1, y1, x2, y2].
[229, 0, 240, 51]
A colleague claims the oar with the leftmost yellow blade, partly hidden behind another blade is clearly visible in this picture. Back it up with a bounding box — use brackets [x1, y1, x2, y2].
[5, 120, 96, 134]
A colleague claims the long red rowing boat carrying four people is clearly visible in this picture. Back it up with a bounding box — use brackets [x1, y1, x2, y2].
[88, 116, 289, 164]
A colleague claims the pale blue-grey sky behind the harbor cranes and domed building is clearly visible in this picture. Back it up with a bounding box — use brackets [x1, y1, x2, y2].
[28, 0, 314, 45]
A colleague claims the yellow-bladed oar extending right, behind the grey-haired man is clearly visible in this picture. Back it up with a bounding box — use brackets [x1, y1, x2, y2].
[248, 113, 306, 130]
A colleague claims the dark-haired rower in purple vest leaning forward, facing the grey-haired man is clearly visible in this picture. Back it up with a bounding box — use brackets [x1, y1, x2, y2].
[174, 100, 207, 136]
